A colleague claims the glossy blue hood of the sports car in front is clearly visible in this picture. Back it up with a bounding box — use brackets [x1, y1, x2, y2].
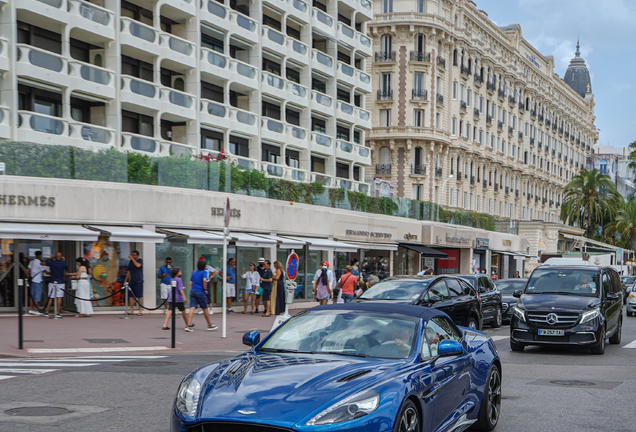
[200, 352, 404, 428]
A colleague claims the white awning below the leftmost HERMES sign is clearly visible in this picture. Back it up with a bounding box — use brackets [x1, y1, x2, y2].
[0, 223, 99, 241]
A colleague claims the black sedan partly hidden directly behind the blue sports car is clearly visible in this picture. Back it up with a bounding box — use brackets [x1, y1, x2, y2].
[354, 276, 482, 329]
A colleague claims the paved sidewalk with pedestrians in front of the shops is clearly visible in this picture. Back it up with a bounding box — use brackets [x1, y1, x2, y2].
[0, 302, 317, 357]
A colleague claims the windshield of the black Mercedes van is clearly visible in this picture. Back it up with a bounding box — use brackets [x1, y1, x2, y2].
[525, 268, 600, 297]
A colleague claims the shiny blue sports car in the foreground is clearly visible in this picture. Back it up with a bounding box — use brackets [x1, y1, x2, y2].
[171, 302, 501, 432]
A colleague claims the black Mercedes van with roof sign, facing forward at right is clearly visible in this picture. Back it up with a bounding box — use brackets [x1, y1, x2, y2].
[510, 265, 623, 354]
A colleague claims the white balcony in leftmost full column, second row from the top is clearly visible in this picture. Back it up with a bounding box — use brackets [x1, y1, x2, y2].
[16, 43, 69, 87]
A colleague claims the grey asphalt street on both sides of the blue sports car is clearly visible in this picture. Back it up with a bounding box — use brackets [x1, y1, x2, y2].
[0, 317, 636, 432]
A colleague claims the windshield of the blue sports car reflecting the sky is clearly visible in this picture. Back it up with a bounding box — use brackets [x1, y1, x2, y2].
[260, 310, 419, 359]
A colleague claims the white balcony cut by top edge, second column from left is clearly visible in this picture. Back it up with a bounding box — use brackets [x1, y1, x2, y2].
[67, 0, 116, 40]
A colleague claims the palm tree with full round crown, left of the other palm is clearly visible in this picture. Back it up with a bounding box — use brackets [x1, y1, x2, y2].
[561, 168, 622, 238]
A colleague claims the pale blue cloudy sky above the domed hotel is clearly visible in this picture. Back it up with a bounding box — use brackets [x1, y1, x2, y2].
[474, 0, 636, 147]
